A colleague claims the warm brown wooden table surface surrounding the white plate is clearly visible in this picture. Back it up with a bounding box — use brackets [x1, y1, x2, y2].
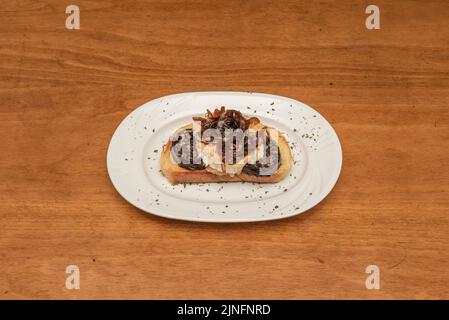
[0, 0, 449, 299]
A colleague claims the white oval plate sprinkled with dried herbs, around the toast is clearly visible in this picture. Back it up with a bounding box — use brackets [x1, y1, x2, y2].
[107, 92, 342, 222]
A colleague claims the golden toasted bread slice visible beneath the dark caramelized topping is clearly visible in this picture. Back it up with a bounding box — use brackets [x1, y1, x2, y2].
[160, 125, 293, 185]
